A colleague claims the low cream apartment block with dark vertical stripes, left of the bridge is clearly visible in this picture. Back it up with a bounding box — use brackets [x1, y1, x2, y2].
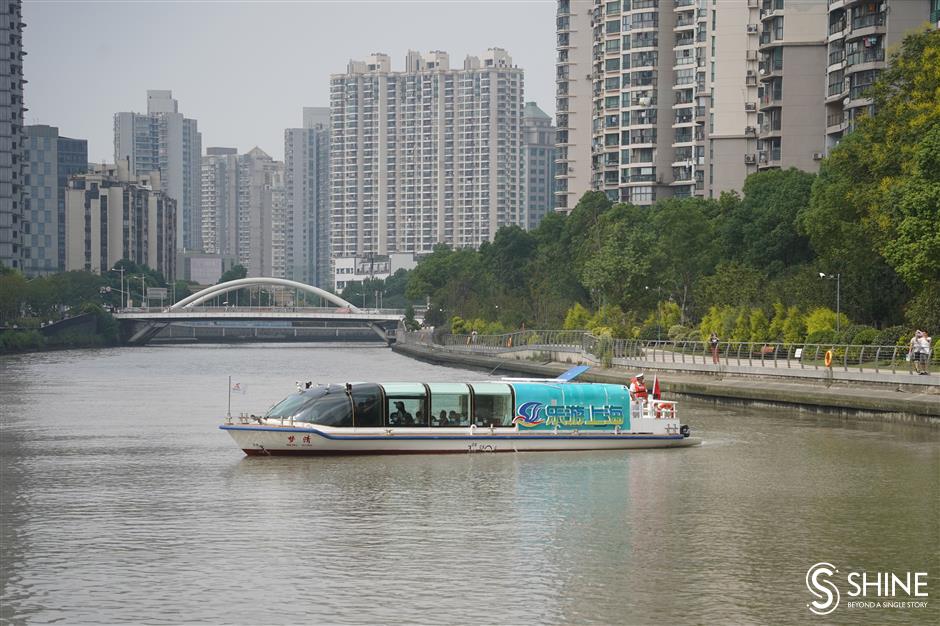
[65, 162, 177, 281]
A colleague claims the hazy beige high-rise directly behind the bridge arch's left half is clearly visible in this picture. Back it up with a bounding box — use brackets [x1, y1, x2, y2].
[202, 148, 286, 278]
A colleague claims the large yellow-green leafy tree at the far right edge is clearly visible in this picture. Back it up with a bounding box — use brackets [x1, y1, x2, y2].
[799, 29, 940, 324]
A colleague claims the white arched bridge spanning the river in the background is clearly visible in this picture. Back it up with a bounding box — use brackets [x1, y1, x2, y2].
[113, 278, 405, 345]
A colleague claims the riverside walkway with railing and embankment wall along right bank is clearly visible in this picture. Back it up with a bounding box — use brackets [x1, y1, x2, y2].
[394, 331, 940, 428]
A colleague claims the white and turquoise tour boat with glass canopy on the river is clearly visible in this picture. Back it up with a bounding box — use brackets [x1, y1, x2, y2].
[219, 366, 701, 456]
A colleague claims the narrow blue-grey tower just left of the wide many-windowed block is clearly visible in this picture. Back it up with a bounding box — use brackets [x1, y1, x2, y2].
[284, 107, 332, 287]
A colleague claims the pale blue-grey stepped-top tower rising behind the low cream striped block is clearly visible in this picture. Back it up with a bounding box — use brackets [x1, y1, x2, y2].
[114, 90, 202, 251]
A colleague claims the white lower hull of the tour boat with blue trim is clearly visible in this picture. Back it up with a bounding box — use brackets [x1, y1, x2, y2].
[219, 424, 701, 456]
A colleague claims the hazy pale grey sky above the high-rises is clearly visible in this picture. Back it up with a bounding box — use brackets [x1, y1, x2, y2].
[23, 0, 556, 162]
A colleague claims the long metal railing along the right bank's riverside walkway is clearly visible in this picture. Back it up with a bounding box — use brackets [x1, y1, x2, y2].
[398, 330, 940, 383]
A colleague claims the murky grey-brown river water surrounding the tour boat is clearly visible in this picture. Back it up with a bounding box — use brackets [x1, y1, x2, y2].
[0, 344, 940, 624]
